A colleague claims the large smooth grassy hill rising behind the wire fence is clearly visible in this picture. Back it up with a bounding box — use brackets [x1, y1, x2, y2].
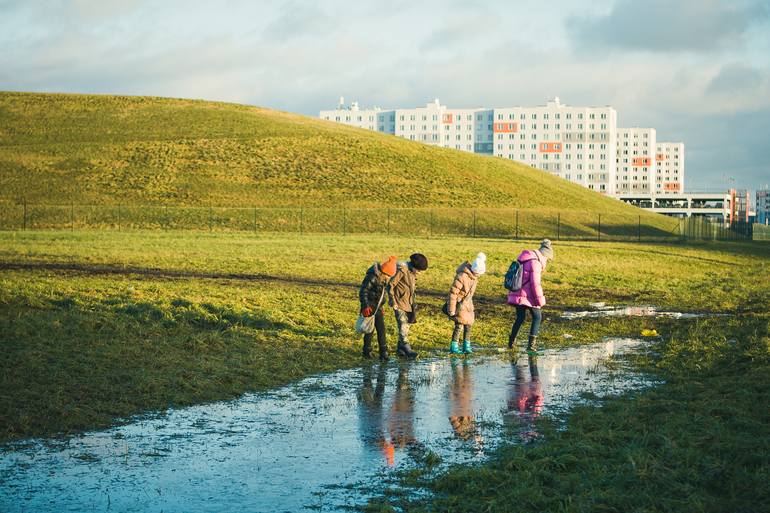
[0, 93, 671, 231]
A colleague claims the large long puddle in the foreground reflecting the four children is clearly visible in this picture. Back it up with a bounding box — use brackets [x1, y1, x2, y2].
[0, 339, 651, 512]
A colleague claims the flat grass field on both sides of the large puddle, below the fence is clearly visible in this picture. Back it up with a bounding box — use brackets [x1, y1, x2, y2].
[0, 231, 770, 512]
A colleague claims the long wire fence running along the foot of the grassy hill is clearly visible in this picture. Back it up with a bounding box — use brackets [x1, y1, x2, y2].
[0, 202, 751, 242]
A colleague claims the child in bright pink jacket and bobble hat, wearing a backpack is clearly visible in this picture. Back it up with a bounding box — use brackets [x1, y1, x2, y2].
[508, 239, 553, 353]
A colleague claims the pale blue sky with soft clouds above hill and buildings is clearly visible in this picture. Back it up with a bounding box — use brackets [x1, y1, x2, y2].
[0, 0, 770, 191]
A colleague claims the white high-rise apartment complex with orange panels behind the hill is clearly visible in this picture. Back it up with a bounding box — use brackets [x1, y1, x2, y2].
[319, 98, 684, 196]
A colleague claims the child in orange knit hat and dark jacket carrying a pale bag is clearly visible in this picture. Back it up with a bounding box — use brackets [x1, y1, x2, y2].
[358, 256, 397, 361]
